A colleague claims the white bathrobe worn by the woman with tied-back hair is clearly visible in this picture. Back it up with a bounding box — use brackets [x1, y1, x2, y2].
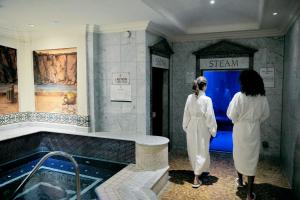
[182, 91, 217, 175]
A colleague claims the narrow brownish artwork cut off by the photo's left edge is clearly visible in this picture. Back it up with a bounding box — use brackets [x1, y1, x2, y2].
[0, 45, 19, 114]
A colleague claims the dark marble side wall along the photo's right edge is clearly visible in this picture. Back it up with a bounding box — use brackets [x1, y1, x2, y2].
[281, 18, 300, 198]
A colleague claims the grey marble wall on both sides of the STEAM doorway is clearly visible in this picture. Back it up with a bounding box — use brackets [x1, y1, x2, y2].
[171, 37, 284, 157]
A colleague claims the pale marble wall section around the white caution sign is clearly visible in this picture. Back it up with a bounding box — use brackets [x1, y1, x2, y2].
[87, 31, 149, 134]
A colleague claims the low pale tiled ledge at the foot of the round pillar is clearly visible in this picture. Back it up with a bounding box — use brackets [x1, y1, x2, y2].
[96, 164, 169, 200]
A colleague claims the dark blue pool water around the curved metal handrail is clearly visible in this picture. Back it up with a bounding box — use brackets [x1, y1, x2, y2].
[0, 153, 126, 200]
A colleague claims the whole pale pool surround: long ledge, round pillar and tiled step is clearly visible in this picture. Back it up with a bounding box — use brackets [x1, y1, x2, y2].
[0, 127, 169, 200]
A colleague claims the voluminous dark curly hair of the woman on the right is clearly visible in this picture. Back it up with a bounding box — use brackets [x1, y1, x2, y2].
[240, 69, 266, 96]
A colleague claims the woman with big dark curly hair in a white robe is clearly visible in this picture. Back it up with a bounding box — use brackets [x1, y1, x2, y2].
[227, 70, 270, 200]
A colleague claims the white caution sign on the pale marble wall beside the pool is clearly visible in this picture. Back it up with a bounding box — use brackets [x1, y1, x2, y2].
[110, 72, 131, 101]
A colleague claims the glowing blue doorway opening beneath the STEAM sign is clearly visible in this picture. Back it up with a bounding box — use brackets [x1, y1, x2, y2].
[202, 70, 240, 152]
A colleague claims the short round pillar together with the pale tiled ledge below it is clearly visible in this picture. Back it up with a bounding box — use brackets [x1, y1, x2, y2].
[96, 136, 169, 200]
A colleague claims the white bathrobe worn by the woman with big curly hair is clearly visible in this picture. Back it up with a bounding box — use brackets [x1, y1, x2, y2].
[227, 92, 270, 176]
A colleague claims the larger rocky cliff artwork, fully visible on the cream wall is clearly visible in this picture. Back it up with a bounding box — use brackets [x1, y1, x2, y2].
[33, 48, 77, 114]
